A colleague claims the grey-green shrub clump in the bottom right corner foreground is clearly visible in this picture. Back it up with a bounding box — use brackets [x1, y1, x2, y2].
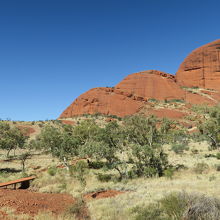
[131, 192, 220, 220]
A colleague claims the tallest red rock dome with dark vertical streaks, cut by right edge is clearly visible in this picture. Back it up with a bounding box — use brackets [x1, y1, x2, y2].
[176, 40, 220, 90]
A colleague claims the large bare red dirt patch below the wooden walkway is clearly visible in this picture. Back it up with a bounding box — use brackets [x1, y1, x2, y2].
[0, 189, 74, 216]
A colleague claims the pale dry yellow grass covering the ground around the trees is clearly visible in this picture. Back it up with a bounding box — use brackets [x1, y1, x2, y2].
[0, 142, 220, 220]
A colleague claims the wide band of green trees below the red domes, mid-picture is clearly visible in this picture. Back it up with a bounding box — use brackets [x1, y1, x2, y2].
[35, 116, 184, 180]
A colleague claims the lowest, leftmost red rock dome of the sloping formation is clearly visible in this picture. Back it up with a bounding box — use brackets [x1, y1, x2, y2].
[60, 88, 144, 118]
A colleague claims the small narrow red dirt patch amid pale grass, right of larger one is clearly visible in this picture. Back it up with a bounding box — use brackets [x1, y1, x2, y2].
[84, 190, 125, 200]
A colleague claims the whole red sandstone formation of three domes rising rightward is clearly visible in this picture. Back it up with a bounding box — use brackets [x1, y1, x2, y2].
[60, 40, 220, 118]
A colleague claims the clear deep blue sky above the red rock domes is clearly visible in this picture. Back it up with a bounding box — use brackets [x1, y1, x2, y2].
[0, 0, 220, 120]
